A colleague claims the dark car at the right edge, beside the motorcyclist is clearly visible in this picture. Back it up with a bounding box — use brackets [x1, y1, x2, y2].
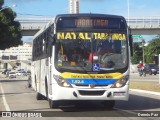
[143, 64, 159, 75]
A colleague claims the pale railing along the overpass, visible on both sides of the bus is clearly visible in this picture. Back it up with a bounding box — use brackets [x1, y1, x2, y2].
[15, 16, 160, 29]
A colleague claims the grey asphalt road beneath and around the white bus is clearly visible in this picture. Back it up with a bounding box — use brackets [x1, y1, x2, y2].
[0, 79, 160, 120]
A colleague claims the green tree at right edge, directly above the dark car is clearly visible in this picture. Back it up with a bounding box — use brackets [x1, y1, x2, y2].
[144, 36, 160, 63]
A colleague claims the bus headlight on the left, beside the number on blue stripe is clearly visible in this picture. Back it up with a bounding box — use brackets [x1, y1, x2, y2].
[53, 75, 72, 87]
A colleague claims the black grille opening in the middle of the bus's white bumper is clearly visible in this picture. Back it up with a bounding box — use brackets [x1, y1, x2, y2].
[79, 90, 105, 96]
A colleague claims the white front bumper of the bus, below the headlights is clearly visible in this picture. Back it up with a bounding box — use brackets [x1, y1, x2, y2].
[49, 84, 129, 100]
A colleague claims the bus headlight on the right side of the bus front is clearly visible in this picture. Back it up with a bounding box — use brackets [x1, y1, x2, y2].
[111, 75, 129, 88]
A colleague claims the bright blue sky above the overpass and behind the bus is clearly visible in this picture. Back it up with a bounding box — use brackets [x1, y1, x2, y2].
[4, 0, 160, 41]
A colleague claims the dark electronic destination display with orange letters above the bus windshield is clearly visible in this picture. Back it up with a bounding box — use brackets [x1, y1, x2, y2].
[56, 17, 127, 30]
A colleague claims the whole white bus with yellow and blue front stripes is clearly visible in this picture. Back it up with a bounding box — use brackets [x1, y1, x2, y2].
[32, 14, 132, 108]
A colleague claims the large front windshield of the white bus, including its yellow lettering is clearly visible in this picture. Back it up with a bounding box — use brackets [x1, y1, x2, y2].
[55, 32, 128, 72]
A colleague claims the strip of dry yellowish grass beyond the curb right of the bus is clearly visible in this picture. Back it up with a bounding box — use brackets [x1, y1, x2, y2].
[130, 81, 160, 92]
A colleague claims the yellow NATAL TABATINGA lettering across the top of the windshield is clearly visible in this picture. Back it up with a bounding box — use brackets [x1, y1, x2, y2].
[57, 32, 126, 40]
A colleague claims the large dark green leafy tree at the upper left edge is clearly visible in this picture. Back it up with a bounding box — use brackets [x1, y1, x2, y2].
[0, 0, 23, 50]
